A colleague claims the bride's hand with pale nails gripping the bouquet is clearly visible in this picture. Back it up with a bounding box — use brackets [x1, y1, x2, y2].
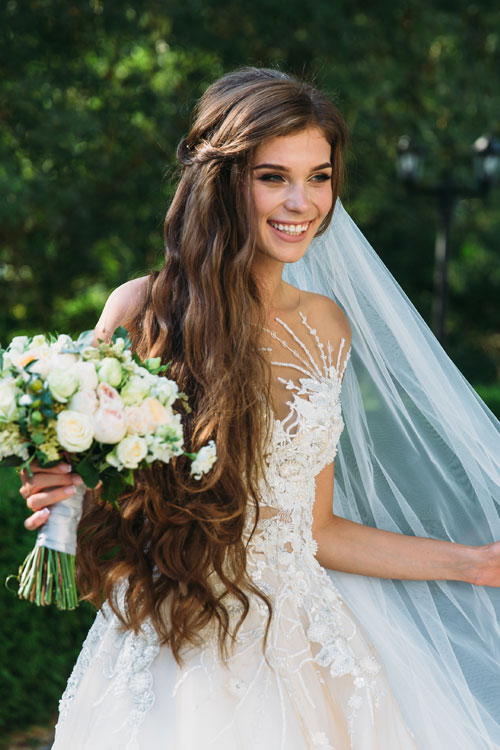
[19, 461, 83, 531]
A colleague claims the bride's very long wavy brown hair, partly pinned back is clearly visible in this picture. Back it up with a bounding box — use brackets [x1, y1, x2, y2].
[78, 67, 347, 663]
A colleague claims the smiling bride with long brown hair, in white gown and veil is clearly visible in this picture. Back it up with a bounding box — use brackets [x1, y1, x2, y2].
[21, 68, 500, 750]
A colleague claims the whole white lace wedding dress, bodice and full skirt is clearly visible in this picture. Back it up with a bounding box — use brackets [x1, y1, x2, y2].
[53, 314, 416, 750]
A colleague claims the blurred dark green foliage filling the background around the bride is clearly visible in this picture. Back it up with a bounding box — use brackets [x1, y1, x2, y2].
[0, 0, 500, 736]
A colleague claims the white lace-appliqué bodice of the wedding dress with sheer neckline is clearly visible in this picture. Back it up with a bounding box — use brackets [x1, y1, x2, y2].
[250, 313, 350, 551]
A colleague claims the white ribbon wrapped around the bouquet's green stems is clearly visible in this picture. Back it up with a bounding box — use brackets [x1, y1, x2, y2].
[37, 484, 87, 555]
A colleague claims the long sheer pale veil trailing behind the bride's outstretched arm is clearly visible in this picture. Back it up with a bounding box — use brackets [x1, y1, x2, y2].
[285, 200, 500, 750]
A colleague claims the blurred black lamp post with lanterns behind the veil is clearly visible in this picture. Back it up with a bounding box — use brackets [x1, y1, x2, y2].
[397, 135, 500, 345]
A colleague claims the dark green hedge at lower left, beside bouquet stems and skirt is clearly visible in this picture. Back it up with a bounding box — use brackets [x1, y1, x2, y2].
[0, 468, 94, 737]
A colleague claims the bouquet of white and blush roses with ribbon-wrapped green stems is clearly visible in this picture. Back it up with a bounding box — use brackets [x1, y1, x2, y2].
[0, 328, 216, 609]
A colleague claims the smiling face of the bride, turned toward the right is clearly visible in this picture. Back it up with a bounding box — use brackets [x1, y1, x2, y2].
[251, 127, 333, 263]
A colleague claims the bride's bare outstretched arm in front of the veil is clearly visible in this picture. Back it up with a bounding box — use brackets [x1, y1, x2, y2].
[313, 464, 500, 586]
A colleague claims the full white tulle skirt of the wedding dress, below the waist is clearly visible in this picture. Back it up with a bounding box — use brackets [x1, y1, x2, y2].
[53, 560, 418, 750]
